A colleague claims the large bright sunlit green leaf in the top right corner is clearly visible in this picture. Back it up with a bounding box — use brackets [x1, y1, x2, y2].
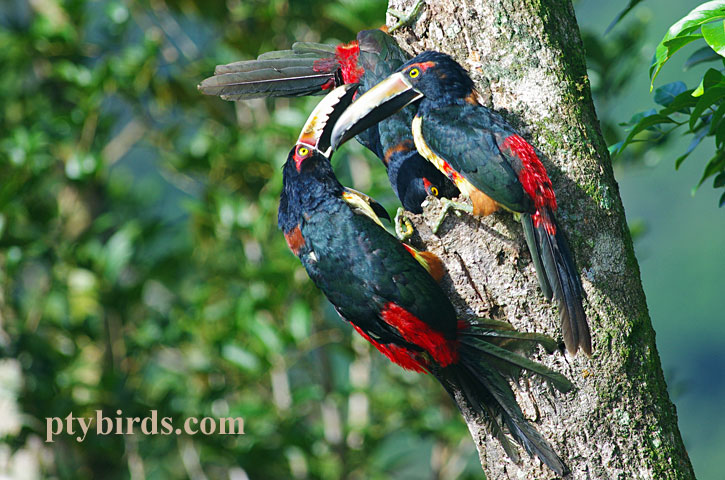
[650, 0, 725, 90]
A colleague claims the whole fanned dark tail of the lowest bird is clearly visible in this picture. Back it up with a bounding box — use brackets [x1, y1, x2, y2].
[432, 324, 572, 476]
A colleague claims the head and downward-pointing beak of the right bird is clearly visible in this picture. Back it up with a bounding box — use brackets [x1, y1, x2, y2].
[331, 51, 474, 146]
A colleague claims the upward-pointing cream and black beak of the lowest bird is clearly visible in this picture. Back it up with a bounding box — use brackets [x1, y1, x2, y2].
[297, 83, 359, 158]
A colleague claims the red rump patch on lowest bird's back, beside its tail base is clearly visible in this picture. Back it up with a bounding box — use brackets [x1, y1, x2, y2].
[380, 302, 458, 367]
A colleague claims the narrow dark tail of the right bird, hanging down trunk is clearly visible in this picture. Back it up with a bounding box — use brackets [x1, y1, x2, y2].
[521, 209, 592, 355]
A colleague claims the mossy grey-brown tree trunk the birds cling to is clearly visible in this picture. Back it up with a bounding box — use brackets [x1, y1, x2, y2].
[388, 0, 694, 479]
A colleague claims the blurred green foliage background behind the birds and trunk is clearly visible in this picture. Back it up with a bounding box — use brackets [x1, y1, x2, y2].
[0, 0, 725, 479]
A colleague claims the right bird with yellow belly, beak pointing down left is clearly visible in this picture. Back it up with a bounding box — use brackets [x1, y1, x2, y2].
[332, 51, 592, 354]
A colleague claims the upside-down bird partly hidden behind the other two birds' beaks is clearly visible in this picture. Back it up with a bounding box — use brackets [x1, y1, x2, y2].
[199, 30, 459, 237]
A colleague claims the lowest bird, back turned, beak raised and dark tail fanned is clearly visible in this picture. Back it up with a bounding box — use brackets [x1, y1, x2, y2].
[278, 86, 572, 475]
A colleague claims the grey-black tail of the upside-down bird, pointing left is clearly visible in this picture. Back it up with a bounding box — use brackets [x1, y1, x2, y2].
[199, 43, 343, 101]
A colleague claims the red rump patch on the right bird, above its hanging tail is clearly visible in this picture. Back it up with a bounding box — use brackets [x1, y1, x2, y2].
[501, 135, 556, 235]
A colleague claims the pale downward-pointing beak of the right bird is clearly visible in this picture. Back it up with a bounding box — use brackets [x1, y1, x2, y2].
[331, 72, 423, 149]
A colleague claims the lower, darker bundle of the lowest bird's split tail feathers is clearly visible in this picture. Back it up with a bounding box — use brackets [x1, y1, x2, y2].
[433, 342, 569, 476]
